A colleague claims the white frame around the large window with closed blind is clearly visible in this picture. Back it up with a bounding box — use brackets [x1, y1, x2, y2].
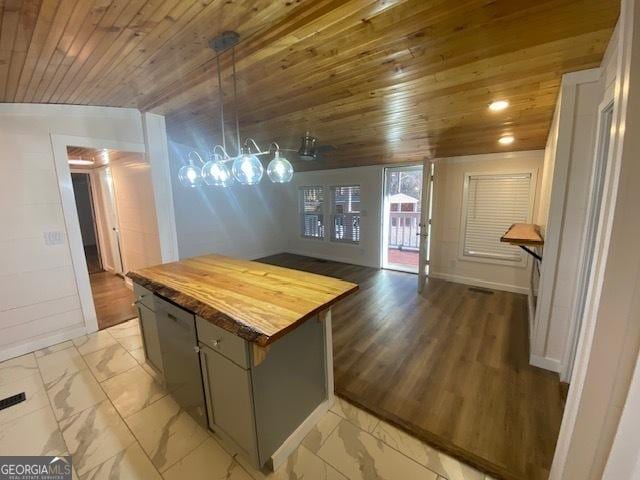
[458, 168, 538, 268]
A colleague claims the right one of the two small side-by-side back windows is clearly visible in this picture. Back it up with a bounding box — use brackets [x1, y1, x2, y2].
[331, 185, 360, 243]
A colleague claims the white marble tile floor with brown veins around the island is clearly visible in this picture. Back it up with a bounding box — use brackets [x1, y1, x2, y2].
[0, 319, 491, 480]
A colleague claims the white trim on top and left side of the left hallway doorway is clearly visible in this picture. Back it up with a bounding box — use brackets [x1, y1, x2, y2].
[51, 133, 145, 333]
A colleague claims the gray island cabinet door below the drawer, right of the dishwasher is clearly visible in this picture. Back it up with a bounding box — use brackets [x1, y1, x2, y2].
[200, 344, 257, 459]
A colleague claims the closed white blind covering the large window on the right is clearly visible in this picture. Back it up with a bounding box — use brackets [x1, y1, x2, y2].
[462, 173, 532, 262]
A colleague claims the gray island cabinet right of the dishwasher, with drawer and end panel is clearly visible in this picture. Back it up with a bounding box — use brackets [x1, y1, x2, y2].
[196, 317, 327, 468]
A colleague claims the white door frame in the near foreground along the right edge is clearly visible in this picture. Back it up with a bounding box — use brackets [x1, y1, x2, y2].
[549, 0, 640, 474]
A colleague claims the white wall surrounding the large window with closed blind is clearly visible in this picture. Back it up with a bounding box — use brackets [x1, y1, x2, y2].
[430, 150, 544, 293]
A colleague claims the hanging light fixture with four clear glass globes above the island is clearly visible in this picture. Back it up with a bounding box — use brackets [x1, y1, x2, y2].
[178, 32, 295, 188]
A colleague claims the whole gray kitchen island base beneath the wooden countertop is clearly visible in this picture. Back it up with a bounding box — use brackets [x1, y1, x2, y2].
[134, 283, 329, 468]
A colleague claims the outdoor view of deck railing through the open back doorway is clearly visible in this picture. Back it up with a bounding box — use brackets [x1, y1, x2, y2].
[382, 165, 423, 273]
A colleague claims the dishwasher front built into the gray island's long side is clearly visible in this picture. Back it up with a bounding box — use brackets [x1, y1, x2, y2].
[155, 296, 207, 428]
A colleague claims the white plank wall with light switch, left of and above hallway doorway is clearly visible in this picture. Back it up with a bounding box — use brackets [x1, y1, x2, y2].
[0, 104, 143, 360]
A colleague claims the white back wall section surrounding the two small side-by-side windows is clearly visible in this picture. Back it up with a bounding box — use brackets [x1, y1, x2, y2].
[283, 165, 384, 268]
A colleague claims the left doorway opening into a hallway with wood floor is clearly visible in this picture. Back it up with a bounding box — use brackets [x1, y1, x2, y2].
[67, 146, 161, 330]
